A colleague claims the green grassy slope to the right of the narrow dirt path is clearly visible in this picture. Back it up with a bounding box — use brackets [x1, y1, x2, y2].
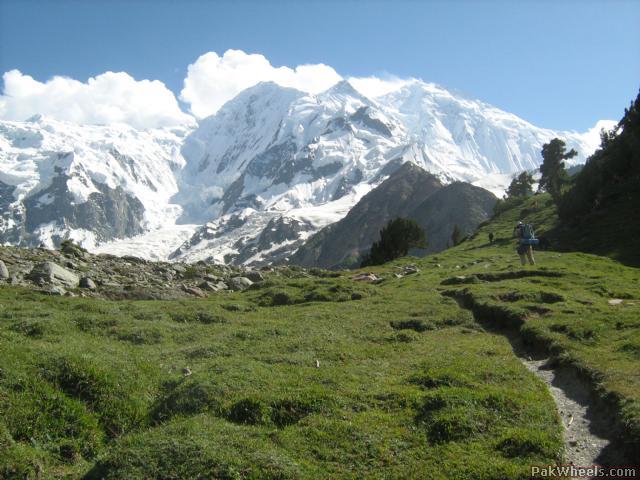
[442, 195, 640, 449]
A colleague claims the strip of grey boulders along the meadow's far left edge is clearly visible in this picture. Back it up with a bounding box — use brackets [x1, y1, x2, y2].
[0, 241, 316, 300]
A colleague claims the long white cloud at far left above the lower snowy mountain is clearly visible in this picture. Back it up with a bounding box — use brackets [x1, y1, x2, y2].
[0, 70, 193, 129]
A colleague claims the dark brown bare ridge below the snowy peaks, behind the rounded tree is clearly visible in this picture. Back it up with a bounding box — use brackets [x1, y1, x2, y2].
[290, 163, 497, 268]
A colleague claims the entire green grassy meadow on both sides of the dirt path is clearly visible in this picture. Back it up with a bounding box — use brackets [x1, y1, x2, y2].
[0, 193, 640, 479]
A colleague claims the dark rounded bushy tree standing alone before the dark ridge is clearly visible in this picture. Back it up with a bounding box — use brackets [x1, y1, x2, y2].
[361, 218, 427, 267]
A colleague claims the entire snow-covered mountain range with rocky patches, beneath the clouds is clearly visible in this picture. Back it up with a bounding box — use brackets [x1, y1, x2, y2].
[0, 81, 608, 263]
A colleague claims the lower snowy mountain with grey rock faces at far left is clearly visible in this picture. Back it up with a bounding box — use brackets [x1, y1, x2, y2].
[0, 116, 194, 256]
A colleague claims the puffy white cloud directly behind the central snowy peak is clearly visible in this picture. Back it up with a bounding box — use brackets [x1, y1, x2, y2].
[180, 50, 342, 118]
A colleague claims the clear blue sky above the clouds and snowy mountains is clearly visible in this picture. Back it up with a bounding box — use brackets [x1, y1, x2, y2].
[0, 0, 640, 131]
